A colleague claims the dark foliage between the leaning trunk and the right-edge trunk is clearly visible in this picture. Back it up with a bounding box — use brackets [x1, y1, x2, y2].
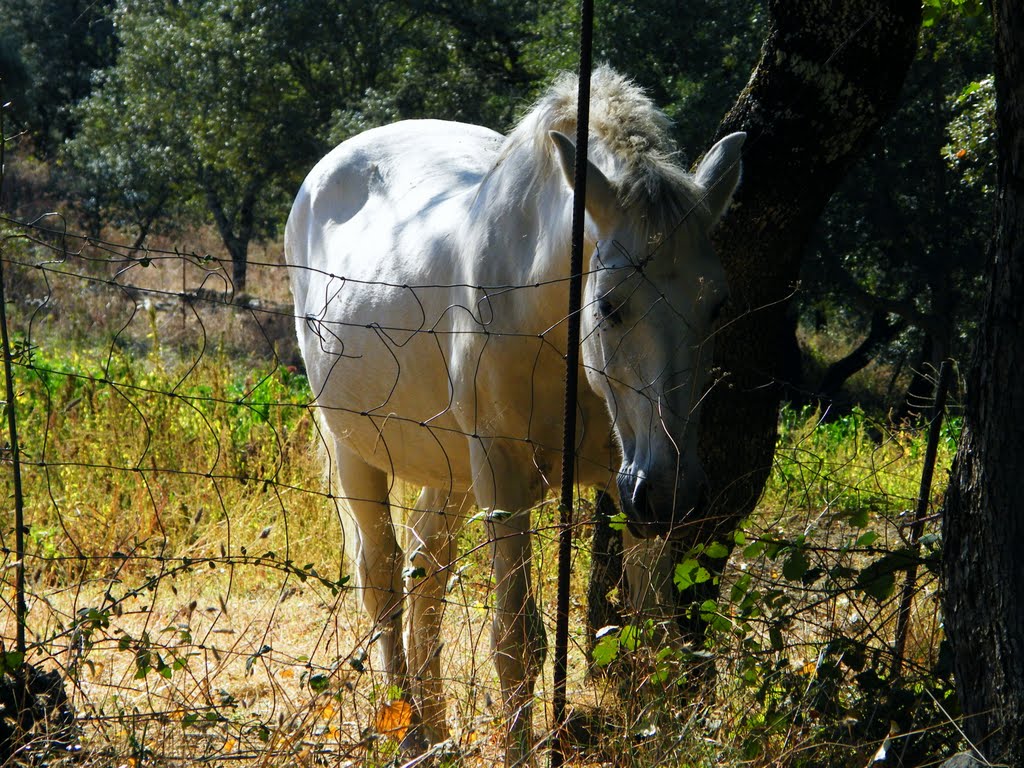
[798, 4, 993, 415]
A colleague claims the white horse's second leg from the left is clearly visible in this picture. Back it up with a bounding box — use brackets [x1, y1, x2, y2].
[406, 488, 466, 743]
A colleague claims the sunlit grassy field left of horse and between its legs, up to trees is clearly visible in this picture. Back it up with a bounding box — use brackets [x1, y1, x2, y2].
[0, 211, 638, 765]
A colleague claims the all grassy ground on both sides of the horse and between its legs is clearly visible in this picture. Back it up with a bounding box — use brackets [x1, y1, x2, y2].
[0, 205, 955, 766]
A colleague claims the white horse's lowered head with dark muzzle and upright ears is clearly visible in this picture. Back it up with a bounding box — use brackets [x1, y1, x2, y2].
[551, 132, 745, 538]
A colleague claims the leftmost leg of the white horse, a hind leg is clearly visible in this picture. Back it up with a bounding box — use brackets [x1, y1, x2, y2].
[335, 443, 408, 692]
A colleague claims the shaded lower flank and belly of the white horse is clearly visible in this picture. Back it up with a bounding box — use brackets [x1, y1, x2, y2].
[300, 279, 471, 492]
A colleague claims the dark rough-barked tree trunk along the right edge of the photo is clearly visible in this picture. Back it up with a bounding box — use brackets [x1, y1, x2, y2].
[943, 0, 1024, 766]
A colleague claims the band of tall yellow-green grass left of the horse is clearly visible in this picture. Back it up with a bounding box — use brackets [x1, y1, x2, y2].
[11, 342, 321, 581]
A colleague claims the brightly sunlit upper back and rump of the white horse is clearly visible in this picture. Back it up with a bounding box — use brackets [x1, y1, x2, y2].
[286, 120, 501, 296]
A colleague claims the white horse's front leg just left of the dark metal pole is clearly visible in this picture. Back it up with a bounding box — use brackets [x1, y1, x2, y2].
[487, 512, 547, 766]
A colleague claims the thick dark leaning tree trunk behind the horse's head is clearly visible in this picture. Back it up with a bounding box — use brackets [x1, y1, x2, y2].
[688, 0, 921, 543]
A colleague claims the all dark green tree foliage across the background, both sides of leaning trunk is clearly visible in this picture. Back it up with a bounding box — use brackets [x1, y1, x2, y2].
[0, 0, 994, 402]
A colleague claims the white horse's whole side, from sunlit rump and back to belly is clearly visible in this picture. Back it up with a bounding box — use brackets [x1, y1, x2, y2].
[285, 121, 503, 484]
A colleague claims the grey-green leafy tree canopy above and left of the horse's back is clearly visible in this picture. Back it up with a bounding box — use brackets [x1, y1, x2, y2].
[57, 0, 552, 290]
